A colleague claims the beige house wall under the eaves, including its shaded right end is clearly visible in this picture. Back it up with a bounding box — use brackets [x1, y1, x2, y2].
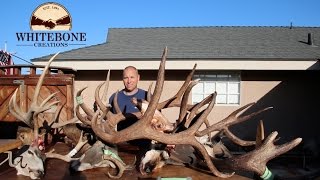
[75, 70, 320, 153]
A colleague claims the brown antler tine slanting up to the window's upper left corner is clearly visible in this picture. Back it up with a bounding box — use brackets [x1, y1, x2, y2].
[157, 64, 197, 110]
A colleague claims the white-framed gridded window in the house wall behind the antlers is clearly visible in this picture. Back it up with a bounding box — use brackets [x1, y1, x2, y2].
[192, 72, 240, 105]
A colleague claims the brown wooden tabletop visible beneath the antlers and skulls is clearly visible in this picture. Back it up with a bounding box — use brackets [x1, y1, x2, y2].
[0, 143, 252, 180]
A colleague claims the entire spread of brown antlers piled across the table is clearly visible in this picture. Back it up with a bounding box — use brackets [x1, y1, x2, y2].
[9, 48, 302, 178]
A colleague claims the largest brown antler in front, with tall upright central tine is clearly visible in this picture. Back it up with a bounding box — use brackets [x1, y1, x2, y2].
[87, 48, 233, 178]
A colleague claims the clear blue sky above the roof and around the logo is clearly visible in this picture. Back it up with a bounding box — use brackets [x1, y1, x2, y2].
[0, 0, 320, 64]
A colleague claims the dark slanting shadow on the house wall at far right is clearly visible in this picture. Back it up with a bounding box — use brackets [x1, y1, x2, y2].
[230, 71, 320, 153]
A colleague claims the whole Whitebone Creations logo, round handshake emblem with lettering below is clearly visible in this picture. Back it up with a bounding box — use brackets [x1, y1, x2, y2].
[16, 2, 87, 47]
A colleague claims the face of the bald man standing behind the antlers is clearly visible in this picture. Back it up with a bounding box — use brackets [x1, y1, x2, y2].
[122, 68, 140, 92]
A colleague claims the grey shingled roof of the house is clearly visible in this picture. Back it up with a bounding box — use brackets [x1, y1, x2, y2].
[32, 26, 320, 61]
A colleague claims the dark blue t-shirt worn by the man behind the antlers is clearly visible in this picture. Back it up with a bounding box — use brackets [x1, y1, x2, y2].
[109, 89, 147, 114]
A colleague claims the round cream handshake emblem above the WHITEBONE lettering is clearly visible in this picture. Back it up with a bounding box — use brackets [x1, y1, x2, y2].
[30, 2, 72, 30]
